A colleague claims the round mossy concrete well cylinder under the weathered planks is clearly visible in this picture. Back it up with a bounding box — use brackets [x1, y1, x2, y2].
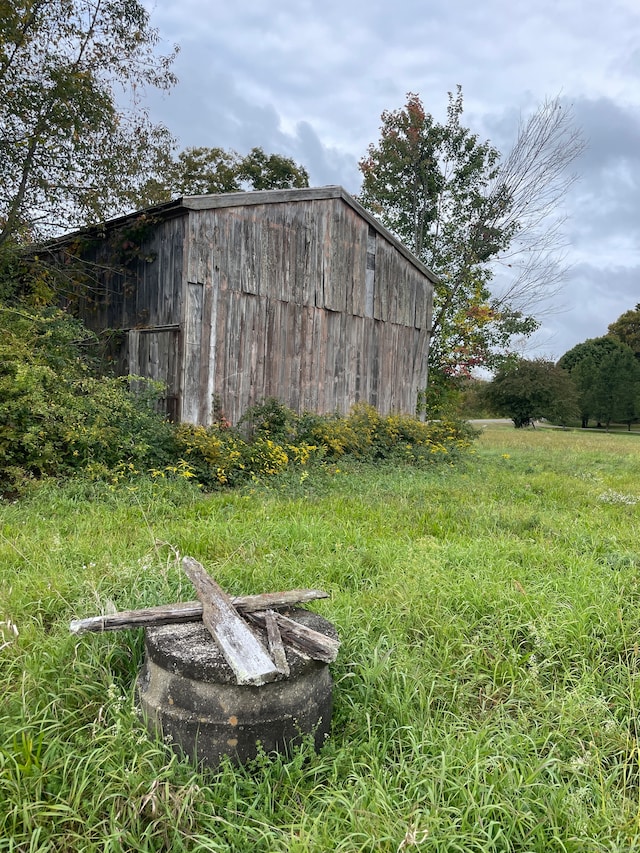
[137, 608, 337, 768]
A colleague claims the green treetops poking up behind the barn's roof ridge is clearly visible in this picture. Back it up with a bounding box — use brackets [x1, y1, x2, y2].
[143, 148, 309, 204]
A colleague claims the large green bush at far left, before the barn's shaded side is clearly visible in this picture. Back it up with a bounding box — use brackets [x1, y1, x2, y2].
[0, 305, 175, 493]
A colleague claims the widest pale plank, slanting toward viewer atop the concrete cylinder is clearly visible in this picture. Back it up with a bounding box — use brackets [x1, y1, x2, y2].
[182, 557, 278, 686]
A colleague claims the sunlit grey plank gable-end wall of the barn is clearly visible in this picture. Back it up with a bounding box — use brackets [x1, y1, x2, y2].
[182, 198, 431, 423]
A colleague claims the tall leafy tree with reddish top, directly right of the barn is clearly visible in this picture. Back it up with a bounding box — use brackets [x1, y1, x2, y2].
[359, 90, 509, 373]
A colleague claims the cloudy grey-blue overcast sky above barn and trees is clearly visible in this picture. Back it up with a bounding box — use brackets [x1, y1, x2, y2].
[145, 0, 640, 358]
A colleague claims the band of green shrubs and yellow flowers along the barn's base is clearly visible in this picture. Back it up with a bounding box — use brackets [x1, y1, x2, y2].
[0, 304, 470, 494]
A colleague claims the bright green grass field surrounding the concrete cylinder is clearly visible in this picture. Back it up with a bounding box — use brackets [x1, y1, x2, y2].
[0, 427, 640, 853]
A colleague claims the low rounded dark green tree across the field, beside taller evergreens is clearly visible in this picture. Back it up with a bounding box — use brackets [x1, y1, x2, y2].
[484, 359, 578, 428]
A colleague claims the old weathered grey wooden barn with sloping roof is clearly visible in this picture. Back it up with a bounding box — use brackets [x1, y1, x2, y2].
[57, 186, 435, 425]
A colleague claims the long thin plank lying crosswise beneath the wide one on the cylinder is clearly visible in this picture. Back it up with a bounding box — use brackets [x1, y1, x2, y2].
[69, 589, 329, 634]
